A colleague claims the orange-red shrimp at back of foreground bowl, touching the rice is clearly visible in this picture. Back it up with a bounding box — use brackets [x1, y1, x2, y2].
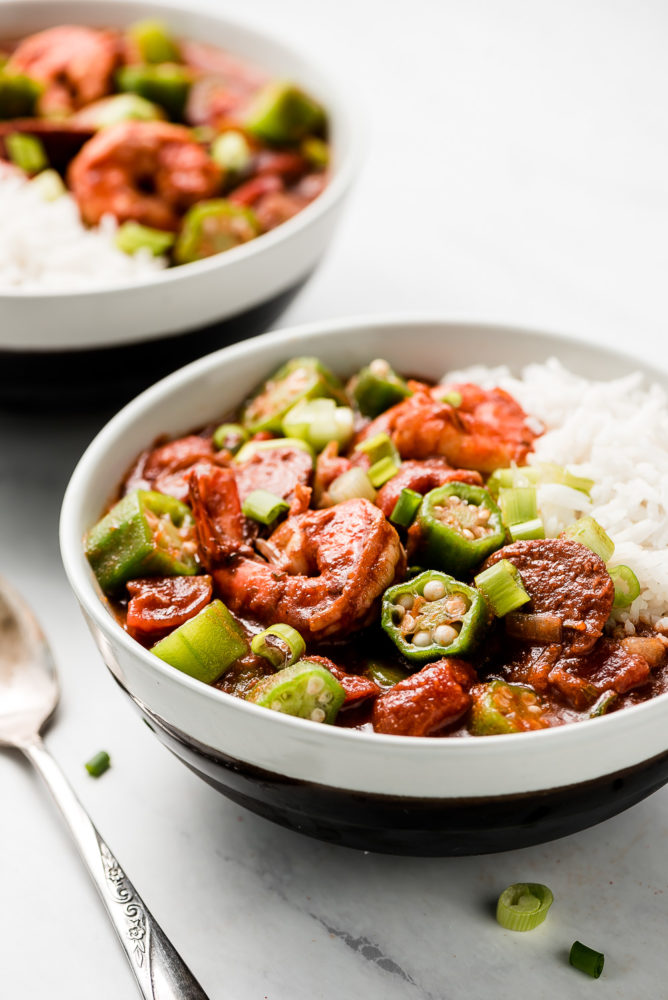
[359, 382, 538, 473]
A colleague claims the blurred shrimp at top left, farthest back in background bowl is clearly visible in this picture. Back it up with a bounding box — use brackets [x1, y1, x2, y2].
[7, 24, 121, 113]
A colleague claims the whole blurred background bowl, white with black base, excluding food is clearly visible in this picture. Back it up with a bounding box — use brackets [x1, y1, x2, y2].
[0, 0, 357, 405]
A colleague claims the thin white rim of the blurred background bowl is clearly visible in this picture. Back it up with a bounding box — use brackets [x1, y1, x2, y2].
[0, 0, 363, 305]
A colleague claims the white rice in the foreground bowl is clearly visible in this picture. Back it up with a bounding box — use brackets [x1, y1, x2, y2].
[443, 358, 668, 633]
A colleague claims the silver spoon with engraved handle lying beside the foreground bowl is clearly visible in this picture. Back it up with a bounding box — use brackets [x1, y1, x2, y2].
[0, 577, 207, 1000]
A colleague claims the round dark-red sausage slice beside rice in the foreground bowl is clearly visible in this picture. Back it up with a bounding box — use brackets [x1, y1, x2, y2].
[484, 538, 615, 656]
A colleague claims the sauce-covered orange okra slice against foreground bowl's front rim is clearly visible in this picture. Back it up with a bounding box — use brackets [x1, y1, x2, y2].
[469, 680, 550, 736]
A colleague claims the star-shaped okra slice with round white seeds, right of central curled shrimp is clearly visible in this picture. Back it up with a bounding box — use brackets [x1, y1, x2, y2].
[381, 570, 489, 663]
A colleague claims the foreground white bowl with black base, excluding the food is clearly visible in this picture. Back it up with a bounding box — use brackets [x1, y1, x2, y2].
[61, 320, 668, 854]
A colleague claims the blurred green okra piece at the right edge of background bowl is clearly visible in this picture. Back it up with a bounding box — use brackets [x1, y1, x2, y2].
[244, 80, 325, 144]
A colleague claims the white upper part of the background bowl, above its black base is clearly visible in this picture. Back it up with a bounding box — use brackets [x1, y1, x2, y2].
[0, 0, 358, 352]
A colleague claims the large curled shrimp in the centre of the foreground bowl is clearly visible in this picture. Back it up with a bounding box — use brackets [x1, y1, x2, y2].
[213, 499, 405, 640]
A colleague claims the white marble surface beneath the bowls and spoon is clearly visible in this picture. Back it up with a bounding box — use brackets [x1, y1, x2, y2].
[0, 0, 668, 1000]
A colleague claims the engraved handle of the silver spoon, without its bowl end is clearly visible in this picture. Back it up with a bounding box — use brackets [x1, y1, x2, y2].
[21, 737, 208, 1000]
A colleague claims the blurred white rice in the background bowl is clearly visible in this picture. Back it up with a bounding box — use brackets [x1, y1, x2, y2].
[0, 167, 167, 292]
